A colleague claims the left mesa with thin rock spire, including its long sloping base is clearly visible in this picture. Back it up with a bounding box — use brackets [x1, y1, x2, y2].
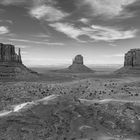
[0, 43, 37, 80]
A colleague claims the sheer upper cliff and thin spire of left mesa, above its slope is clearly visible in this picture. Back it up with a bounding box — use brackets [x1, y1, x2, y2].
[0, 43, 22, 63]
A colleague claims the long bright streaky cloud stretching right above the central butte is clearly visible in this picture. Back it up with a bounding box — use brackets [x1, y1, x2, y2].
[50, 22, 136, 42]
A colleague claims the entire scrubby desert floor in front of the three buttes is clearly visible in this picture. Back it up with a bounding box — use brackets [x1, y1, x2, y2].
[0, 73, 140, 140]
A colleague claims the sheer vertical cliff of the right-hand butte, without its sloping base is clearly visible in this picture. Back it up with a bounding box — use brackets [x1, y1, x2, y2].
[124, 49, 140, 67]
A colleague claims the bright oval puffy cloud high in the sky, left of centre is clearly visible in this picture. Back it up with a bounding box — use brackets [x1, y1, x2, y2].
[30, 4, 68, 22]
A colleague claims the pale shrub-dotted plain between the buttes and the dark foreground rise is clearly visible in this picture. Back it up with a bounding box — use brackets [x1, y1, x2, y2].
[0, 78, 140, 110]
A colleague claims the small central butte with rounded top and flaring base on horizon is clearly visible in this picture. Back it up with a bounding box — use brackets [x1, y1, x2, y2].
[54, 55, 94, 73]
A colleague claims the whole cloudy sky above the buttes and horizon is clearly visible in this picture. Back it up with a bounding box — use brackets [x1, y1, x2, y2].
[0, 0, 140, 66]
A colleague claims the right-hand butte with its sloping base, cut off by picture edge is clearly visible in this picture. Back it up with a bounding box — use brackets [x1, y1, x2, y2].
[116, 49, 140, 74]
